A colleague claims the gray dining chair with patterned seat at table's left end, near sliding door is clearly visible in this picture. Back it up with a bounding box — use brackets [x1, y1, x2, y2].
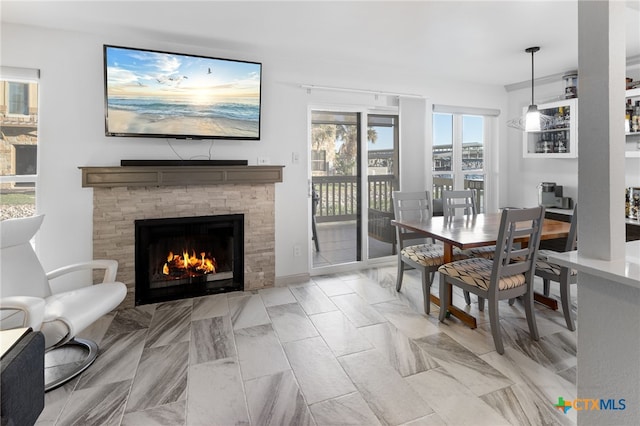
[392, 191, 466, 314]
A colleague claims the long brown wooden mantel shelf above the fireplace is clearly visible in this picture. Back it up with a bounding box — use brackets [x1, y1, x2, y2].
[79, 166, 284, 188]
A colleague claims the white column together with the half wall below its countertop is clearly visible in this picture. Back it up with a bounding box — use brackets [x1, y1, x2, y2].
[577, 0, 640, 425]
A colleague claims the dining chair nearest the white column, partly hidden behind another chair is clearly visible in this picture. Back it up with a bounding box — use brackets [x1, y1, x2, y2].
[535, 204, 578, 331]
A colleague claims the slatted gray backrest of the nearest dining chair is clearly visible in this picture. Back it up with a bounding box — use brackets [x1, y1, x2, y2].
[491, 206, 544, 291]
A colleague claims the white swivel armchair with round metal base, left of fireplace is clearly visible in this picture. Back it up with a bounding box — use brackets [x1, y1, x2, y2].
[0, 215, 127, 390]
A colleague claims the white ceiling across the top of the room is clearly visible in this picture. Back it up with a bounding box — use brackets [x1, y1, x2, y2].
[0, 0, 640, 85]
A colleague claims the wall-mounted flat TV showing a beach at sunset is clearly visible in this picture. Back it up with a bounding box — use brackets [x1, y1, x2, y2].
[104, 46, 262, 139]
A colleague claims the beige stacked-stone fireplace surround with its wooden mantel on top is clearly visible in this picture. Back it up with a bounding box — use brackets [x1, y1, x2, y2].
[81, 166, 282, 308]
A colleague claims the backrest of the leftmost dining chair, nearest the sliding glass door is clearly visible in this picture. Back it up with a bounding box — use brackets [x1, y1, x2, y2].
[391, 191, 433, 249]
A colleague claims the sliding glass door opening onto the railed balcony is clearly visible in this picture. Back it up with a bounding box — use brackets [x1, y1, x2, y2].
[310, 110, 398, 268]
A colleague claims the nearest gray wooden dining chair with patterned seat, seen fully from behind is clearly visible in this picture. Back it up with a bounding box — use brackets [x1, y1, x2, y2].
[438, 206, 544, 354]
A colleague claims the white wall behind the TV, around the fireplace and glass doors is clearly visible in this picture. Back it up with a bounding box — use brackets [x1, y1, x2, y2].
[0, 24, 510, 278]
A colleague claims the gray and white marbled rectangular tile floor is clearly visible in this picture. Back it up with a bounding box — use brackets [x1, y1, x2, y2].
[37, 267, 576, 426]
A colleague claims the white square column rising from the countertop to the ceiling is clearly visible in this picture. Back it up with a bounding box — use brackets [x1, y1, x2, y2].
[578, 0, 626, 260]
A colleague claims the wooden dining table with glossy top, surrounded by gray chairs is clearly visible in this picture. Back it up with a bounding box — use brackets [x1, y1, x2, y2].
[391, 213, 570, 328]
